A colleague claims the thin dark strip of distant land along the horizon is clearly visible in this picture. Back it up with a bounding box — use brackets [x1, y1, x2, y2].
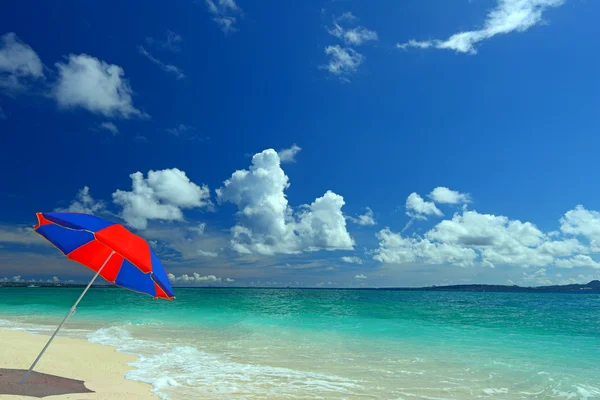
[0, 280, 600, 294]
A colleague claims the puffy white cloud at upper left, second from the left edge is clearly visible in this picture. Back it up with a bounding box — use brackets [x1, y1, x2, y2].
[54, 54, 147, 118]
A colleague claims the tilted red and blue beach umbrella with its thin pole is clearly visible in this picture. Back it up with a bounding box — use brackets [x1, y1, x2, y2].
[19, 213, 175, 383]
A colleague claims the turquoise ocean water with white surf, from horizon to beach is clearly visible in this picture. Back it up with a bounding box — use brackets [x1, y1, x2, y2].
[0, 288, 600, 400]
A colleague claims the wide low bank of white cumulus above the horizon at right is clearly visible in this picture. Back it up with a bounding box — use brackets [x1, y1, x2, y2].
[373, 208, 600, 268]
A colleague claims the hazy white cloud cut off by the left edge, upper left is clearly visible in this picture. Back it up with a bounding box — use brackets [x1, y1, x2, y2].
[0, 32, 44, 90]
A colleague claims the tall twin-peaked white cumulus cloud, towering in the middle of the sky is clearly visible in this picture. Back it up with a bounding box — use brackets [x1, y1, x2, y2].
[216, 149, 354, 255]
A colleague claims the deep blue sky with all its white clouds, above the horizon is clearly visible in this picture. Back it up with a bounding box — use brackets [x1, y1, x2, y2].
[0, 0, 600, 286]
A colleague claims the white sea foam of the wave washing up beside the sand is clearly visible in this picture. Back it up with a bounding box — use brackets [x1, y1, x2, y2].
[88, 325, 360, 399]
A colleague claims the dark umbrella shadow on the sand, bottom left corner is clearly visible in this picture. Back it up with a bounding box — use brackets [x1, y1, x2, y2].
[0, 368, 94, 398]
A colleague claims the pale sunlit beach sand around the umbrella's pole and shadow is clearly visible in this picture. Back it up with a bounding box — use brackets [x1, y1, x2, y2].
[0, 329, 160, 400]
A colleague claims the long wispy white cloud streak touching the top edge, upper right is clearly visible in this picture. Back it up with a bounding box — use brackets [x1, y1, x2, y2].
[397, 0, 564, 54]
